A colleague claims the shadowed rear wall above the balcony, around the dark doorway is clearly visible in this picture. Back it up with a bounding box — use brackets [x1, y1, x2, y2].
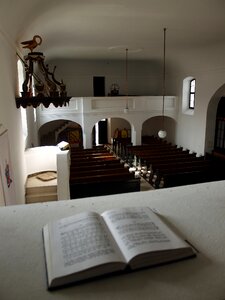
[46, 55, 164, 97]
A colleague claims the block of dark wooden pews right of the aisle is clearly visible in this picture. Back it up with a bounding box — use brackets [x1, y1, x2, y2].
[127, 137, 225, 188]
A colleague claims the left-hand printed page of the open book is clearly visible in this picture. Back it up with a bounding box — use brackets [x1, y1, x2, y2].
[46, 212, 125, 277]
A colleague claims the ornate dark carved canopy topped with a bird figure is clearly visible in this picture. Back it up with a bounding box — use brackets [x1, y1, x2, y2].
[16, 35, 71, 108]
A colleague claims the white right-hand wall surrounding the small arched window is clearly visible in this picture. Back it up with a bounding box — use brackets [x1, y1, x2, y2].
[173, 44, 225, 154]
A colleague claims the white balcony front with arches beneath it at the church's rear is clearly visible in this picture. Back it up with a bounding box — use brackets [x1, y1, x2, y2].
[37, 96, 178, 148]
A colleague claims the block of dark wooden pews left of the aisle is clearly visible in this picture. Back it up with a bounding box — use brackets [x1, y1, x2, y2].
[70, 148, 140, 199]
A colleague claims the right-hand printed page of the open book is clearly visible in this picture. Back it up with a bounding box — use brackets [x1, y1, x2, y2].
[102, 207, 190, 262]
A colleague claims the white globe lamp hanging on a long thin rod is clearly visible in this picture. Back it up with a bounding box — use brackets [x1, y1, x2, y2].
[158, 28, 167, 139]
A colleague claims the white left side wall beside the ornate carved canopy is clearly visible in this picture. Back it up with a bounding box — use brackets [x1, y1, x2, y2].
[0, 31, 25, 204]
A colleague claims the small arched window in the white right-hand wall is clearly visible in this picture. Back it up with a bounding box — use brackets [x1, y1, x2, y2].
[182, 76, 196, 115]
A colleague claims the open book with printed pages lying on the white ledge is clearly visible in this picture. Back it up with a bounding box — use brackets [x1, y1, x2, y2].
[43, 207, 195, 289]
